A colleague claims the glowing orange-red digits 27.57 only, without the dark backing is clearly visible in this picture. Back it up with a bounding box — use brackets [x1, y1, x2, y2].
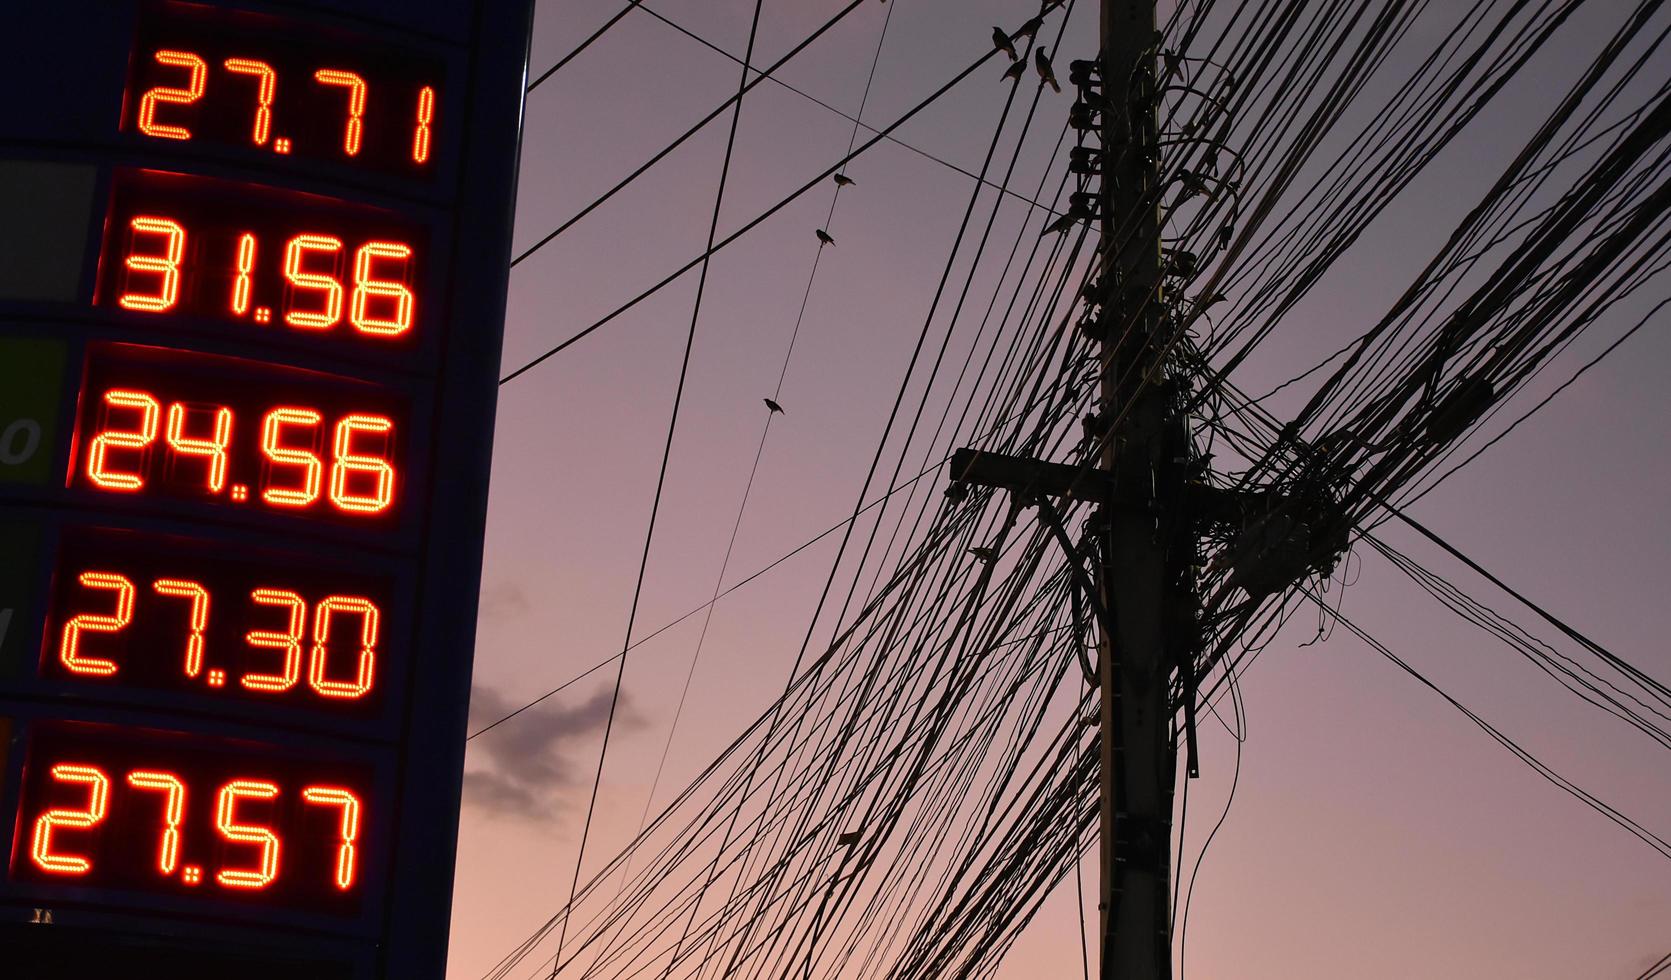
[28, 763, 361, 891]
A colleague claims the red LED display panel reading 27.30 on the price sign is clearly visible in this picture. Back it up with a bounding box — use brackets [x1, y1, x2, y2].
[40, 530, 399, 717]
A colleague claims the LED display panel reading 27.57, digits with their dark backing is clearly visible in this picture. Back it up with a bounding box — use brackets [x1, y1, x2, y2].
[10, 712, 378, 915]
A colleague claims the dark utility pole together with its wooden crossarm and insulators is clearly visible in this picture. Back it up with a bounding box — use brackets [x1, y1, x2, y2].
[951, 0, 1189, 980]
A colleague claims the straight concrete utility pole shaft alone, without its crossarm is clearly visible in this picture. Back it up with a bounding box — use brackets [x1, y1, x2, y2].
[1098, 0, 1181, 980]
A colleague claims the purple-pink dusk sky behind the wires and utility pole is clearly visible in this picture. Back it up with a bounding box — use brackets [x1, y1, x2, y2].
[449, 0, 1671, 980]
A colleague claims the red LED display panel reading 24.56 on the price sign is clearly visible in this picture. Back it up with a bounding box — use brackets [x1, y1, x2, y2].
[69, 345, 408, 523]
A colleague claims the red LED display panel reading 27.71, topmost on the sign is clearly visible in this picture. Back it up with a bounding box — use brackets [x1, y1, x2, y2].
[122, 3, 444, 176]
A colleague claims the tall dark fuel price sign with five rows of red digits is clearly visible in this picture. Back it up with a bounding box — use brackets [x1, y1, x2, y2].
[0, 0, 531, 980]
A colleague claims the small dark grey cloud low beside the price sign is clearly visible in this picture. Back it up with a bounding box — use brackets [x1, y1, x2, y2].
[465, 686, 643, 819]
